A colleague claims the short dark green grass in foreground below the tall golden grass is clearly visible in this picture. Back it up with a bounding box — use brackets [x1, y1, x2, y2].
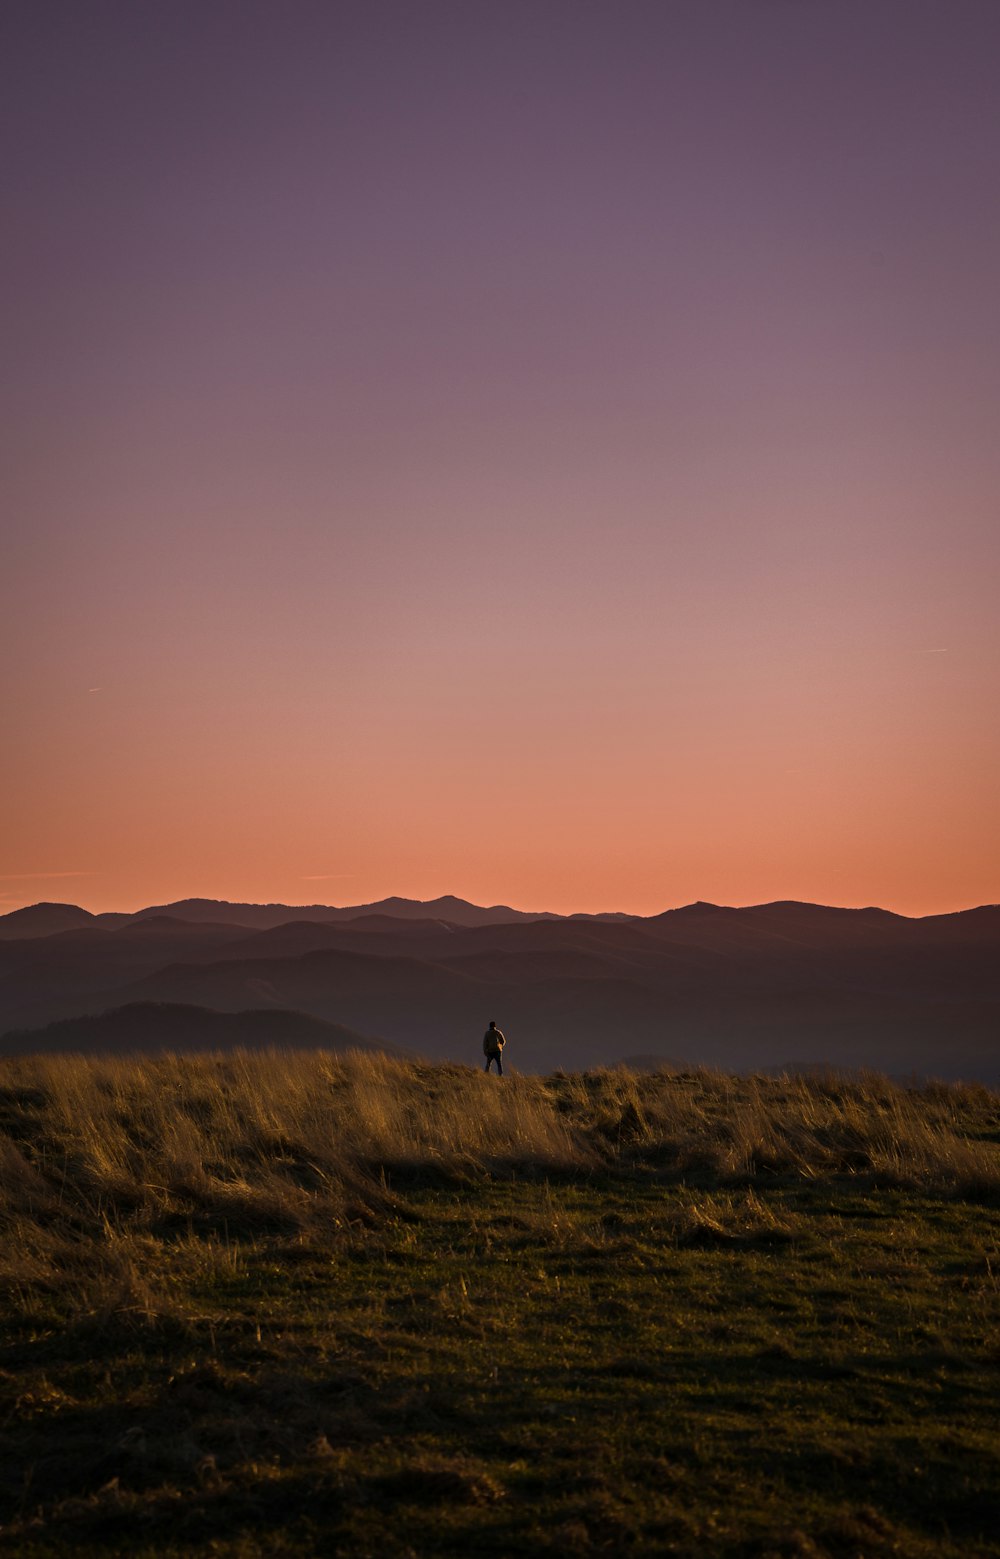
[0, 1174, 1000, 1559]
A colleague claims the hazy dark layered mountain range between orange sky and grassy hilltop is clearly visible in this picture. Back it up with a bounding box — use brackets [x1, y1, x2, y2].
[0, 896, 1000, 1084]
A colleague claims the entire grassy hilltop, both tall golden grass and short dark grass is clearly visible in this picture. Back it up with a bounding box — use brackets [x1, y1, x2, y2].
[0, 1054, 1000, 1559]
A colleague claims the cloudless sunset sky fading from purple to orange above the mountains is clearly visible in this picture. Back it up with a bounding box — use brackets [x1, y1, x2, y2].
[0, 0, 1000, 914]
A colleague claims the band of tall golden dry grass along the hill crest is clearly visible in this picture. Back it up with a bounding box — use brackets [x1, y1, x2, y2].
[0, 1052, 1000, 1320]
